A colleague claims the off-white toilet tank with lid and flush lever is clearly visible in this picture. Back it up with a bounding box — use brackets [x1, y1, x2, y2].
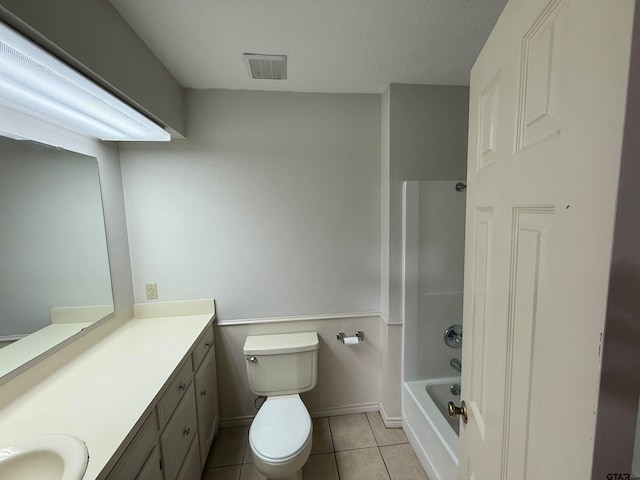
[243, 332, 320, 397]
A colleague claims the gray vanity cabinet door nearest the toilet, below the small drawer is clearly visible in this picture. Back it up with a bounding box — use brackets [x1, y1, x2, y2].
[195, 347, 218, 466]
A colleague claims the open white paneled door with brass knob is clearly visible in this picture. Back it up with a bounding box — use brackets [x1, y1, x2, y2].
[459, 0, 634, 480]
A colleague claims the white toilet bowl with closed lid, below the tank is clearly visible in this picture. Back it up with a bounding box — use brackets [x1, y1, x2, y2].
[249, 395, 313, 480]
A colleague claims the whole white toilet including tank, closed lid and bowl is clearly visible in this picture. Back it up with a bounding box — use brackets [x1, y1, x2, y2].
[243, 332, 319, 480]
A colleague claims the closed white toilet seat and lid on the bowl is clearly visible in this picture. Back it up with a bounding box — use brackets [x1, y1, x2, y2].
[249, 395, 312, 464]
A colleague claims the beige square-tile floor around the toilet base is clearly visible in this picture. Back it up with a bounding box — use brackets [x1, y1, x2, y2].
[201, 412, 428, 480]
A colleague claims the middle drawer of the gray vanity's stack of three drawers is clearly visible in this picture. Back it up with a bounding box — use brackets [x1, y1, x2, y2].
[160, 385, 198, 480]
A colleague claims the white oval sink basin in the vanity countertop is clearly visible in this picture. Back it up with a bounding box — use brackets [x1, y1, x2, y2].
[0, 434, 89, 480]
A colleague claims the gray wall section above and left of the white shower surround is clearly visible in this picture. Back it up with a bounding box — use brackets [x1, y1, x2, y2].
[381, 84, 469, 322]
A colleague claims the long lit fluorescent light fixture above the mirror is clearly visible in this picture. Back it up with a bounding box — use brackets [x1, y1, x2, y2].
[0, 22, 171, 141]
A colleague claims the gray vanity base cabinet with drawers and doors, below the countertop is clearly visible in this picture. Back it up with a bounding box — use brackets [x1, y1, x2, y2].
[102, 325, 218, 480]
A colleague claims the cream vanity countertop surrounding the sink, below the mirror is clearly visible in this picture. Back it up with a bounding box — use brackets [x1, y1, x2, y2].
[0, 301, 215, 480]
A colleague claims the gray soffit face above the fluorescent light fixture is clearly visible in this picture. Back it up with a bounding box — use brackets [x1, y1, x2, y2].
[0, 0, 186, 135]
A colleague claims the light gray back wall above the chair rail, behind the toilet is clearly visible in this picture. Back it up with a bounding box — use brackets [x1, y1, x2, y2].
[120, 90, 381, 321]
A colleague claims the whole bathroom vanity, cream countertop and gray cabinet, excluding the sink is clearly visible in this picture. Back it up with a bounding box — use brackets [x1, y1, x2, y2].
[0, 301, 218, 480]
